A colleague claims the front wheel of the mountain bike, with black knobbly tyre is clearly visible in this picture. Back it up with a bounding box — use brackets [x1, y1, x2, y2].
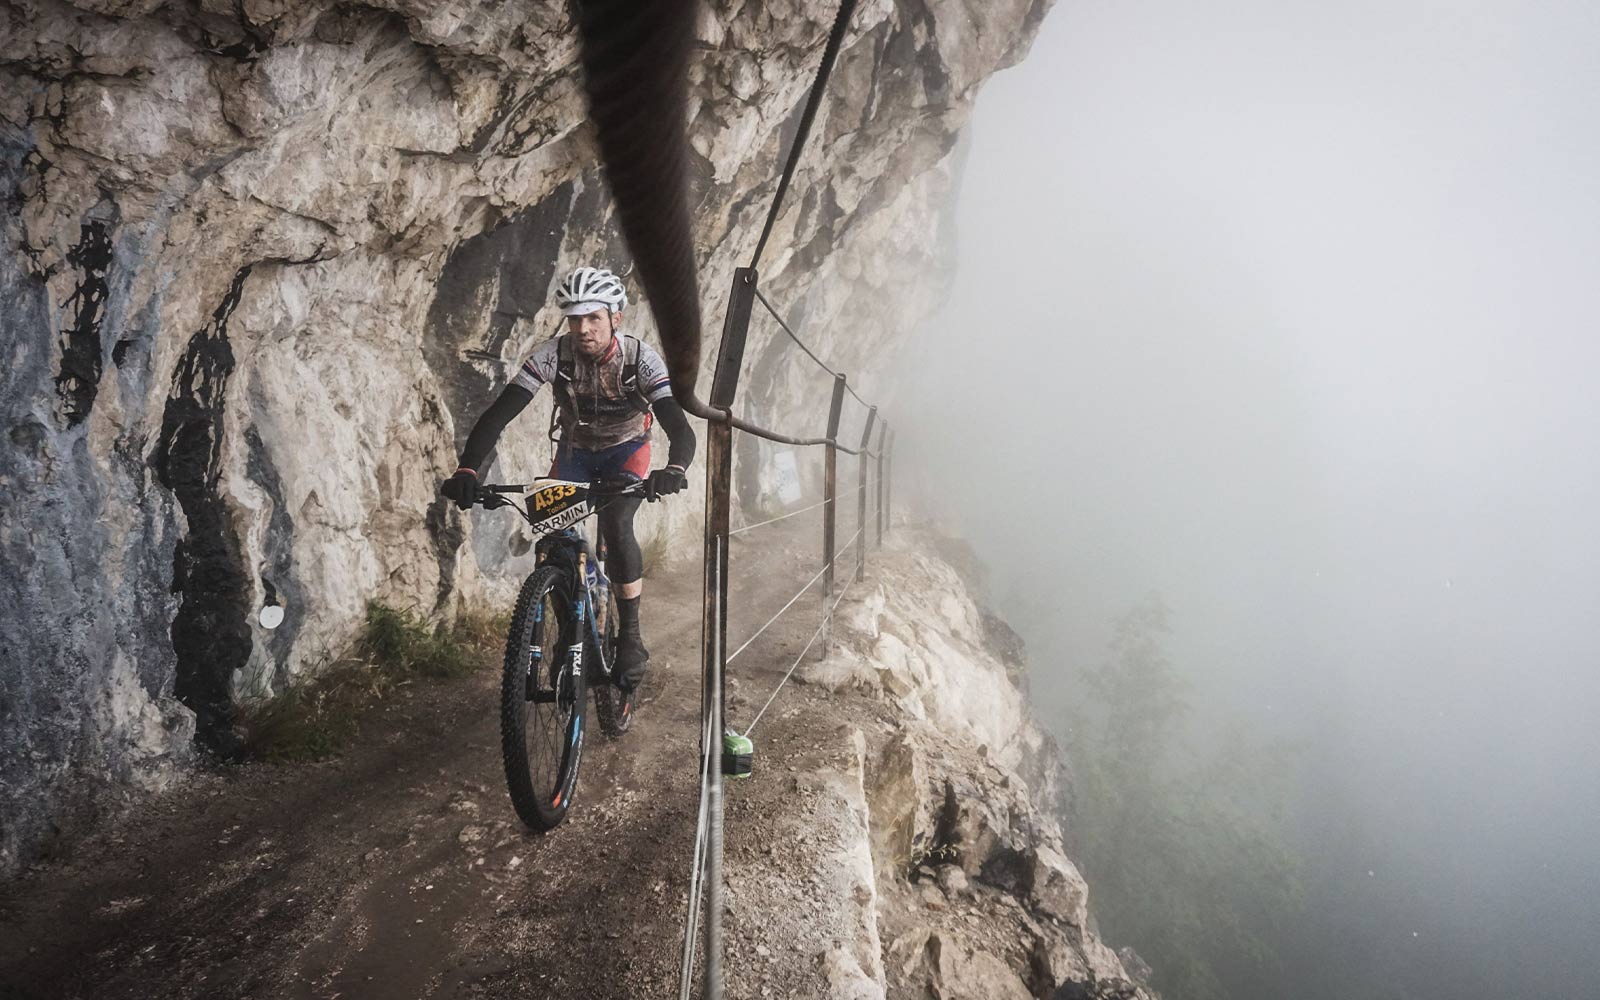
[501, 566, 584, 832]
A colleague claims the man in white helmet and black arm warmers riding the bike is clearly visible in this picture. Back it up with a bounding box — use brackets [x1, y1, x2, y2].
[440, 267, 694, 691]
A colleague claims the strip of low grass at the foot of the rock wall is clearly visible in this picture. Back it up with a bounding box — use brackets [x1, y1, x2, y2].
[240, 600, 510, 763]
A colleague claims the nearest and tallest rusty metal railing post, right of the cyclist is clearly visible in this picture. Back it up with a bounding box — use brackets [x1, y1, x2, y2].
[701, 267, 757, 1000]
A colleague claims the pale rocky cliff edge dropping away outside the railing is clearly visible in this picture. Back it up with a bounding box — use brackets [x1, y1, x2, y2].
[728, 525, 1155, 1000]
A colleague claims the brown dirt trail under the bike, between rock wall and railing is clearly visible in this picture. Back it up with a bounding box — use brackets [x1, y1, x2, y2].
[0, 517, 876, 1000]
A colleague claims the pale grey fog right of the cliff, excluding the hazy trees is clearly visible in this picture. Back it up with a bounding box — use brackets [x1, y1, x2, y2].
[894, 0, 1600, 997]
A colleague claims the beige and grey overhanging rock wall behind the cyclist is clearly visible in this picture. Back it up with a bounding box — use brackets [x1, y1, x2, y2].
[0, 0, 1048, 870]
